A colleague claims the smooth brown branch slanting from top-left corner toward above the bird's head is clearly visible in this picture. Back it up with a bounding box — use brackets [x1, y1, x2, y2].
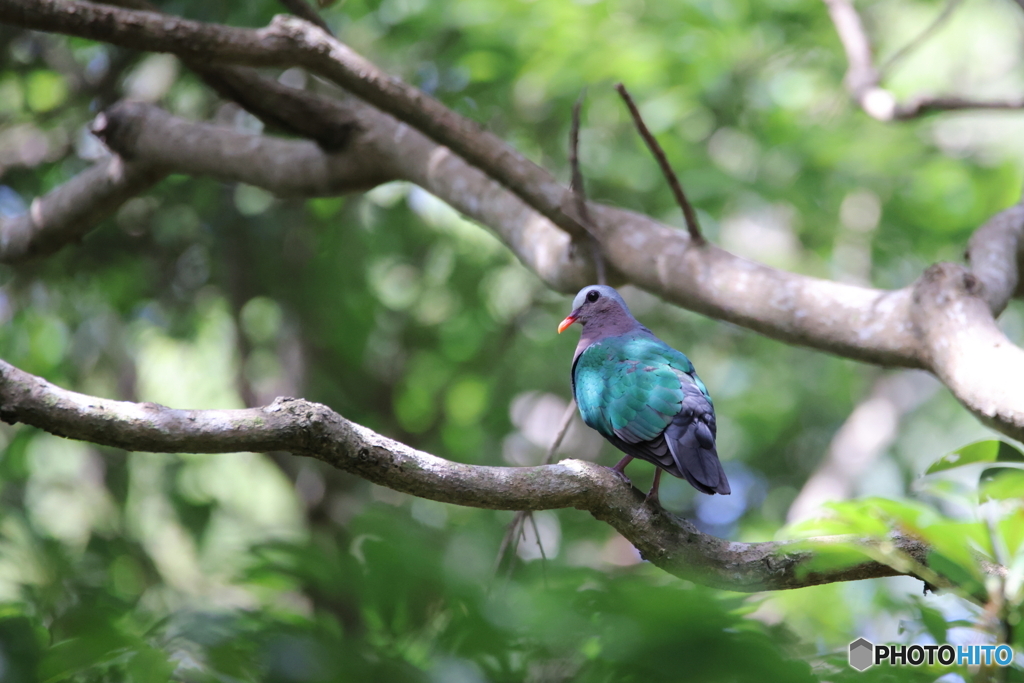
[0, 0, 587, 238]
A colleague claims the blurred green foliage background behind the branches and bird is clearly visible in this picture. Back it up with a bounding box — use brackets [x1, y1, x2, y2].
[0, 0, 1024, 683]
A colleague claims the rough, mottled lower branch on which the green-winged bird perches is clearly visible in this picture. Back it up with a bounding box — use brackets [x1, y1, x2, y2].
[0, 360, 928, 592]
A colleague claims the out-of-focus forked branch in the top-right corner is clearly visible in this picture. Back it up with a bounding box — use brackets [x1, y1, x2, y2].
[823, 0, 1024, 121]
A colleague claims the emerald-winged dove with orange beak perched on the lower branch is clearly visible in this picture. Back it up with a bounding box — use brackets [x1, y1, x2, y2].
[558, 285, 730, 500]
